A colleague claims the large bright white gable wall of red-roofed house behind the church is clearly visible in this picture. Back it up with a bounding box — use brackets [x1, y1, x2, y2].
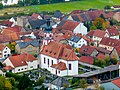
[73, 23, 87, 35]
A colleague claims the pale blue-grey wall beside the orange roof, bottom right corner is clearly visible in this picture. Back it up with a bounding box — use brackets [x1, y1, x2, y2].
[101, 82, 120, 90]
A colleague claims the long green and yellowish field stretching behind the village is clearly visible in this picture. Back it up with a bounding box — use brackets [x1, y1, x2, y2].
[0, 0, 120, 16]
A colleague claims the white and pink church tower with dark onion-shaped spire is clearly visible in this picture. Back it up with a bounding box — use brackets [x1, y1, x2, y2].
[43, 19, 53, 45]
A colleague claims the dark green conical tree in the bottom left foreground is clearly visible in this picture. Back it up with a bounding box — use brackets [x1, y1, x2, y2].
[18, 74, 31, 90]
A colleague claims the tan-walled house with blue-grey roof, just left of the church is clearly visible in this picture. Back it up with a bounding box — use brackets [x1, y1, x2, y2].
[15, 40, 40, 55]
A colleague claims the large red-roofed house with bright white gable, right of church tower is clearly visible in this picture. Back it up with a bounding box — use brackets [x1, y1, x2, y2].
[57, 20, 87, 35]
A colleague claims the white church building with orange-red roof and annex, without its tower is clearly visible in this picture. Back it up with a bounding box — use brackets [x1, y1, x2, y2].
[40, 41, 79, 76]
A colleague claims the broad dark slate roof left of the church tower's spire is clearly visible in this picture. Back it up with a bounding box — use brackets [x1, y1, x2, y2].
[29, 19, 46, 29]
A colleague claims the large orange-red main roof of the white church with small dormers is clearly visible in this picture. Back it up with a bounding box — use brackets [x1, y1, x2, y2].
[41, 41, 78, 60]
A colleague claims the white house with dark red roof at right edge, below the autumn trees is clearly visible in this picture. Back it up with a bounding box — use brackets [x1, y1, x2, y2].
[106, 26, 119, 39]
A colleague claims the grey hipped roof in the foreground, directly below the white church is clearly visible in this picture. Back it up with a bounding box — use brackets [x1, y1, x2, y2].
[51, 77, 69, 87]
